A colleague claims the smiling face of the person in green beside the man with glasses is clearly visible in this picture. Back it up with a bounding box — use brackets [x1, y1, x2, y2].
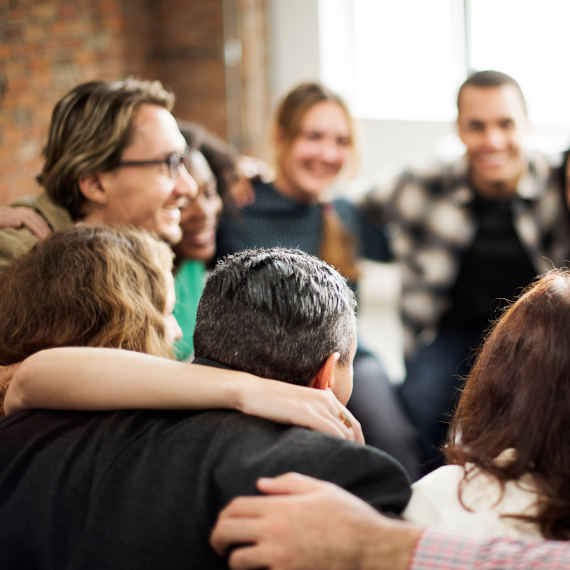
[175, 151, 222, 261]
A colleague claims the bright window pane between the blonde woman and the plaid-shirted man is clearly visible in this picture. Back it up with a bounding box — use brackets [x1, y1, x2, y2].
[352, 0, 456, 120]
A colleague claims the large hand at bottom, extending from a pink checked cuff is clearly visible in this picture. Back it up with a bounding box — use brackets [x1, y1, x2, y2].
[210, 473, 422, 570]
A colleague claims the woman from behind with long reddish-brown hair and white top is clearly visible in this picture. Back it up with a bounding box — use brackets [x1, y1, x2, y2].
[405, 270, 570, 540]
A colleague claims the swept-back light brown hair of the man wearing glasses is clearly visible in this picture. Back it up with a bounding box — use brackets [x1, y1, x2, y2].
[38, 78, 174, 219]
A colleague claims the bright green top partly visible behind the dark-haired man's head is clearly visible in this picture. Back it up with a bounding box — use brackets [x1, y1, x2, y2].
[174, 259, 206, 360]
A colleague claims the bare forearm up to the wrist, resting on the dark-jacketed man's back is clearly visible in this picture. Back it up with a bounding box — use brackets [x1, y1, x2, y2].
[5, 347, 245, 413]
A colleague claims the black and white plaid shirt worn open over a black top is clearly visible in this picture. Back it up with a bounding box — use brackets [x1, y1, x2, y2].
[362, 153, 570, 355]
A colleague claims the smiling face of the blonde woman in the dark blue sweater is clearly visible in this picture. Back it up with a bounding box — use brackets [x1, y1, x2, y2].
[275, 101, 352, 202]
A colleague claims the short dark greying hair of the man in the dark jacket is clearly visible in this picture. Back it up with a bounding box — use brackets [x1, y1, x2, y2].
[194, 248, 356, 386]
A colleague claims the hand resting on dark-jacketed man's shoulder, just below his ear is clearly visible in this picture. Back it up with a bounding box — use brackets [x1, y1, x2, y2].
[238, 379, 364, 443]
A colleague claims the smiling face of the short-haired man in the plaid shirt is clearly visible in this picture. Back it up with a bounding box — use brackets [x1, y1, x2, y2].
[457, 84, 528, 198]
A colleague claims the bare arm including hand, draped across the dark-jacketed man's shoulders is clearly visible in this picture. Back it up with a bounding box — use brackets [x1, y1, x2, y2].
[4, 347, 363, 441]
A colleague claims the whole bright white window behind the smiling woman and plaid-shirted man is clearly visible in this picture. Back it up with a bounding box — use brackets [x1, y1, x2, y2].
[319, 0, 570, 132]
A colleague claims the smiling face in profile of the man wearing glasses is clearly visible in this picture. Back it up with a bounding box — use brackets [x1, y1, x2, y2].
[85, 104, 196, 243]
